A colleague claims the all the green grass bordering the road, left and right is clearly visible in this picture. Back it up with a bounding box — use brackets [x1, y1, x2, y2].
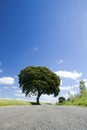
[0, 95, 87, 106]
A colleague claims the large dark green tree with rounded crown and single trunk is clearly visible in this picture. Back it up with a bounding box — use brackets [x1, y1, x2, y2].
[18, 66, 60, 104]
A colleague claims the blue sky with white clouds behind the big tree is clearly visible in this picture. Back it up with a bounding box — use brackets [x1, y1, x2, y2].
[0, 0, 87, 102]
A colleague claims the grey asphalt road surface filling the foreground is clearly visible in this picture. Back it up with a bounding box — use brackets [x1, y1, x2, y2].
[0, 105, 87, 130]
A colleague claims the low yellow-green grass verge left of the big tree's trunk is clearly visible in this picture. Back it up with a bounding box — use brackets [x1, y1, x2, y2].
[0, 99, 31, 106]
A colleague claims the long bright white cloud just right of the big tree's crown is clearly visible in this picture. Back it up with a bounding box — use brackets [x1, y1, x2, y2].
[55, 71, 82, 80]
